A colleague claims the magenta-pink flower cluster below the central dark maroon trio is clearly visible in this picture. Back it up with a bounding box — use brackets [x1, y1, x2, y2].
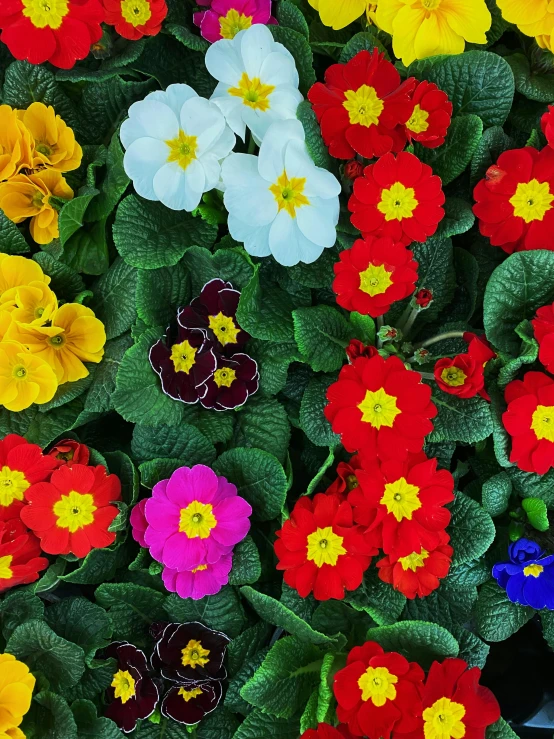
[131, 465, 252, 600]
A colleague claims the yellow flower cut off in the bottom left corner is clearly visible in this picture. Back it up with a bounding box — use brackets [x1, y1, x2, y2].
[0, 654, 36, 737]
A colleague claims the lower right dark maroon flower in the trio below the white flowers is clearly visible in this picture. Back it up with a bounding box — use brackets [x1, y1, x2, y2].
[198, 353, 260, 411]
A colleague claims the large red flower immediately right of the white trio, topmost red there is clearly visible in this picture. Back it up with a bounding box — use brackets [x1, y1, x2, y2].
[308, 49, 415, 159]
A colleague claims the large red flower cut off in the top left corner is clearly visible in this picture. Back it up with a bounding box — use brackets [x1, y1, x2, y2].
[0, 0, 104, 69]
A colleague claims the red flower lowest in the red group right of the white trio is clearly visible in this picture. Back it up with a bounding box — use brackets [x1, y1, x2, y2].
[333, 236, 418, 318]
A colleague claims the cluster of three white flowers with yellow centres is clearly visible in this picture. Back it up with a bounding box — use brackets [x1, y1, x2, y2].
[121, 24, 340, 266]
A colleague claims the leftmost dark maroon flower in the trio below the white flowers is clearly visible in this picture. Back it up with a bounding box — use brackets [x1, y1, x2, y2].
[150, 326, 217, 403]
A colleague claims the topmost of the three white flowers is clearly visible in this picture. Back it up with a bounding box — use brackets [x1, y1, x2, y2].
[206, 23, 303, 144]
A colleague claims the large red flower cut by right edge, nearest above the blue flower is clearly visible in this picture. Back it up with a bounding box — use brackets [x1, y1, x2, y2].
[502, 372, 554, 475]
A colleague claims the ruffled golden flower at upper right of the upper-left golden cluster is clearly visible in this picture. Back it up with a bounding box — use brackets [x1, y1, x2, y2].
[18, 103, 83, 172]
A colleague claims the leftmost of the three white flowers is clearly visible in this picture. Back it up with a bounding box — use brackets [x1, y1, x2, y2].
[120, 85, 236, 211]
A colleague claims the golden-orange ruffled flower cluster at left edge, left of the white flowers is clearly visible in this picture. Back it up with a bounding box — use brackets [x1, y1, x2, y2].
[0, 103, 83, 244]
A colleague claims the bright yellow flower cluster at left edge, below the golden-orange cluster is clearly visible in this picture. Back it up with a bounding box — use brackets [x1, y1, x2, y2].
[0, 254, 106, 411]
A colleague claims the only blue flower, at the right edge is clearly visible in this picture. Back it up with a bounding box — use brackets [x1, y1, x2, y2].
[492, 539, 554, 611]
